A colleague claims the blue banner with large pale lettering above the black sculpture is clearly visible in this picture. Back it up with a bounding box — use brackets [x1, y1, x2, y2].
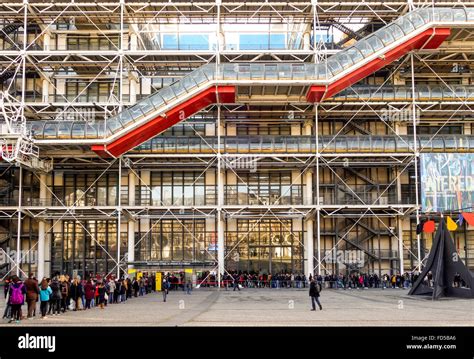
[420, 153, 474, 212]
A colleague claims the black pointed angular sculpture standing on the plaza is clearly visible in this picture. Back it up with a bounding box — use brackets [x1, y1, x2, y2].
[408, 219, 474, 299]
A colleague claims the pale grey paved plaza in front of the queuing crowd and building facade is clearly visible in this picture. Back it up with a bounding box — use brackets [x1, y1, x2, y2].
[0, 288, 474, 326]
